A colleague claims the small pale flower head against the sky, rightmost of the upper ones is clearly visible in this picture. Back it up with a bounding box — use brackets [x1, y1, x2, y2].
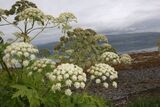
[57, 12, 77, 23]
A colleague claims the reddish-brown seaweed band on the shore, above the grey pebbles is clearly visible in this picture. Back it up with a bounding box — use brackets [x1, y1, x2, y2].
[114, 51, 160, 70]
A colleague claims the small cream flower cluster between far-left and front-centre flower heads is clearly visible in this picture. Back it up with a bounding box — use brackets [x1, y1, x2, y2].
[28, 58, 56, 72]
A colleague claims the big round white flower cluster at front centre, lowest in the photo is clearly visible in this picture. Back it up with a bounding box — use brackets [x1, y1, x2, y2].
[47, 63, 86, 96]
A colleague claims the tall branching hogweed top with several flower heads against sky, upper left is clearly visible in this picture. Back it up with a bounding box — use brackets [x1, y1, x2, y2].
[0, 0, 77, 42]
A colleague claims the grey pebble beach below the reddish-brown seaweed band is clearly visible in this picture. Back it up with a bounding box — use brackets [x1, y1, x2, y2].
[89, 67, 160, 103]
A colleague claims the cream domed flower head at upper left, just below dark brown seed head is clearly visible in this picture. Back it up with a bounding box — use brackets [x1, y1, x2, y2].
[18, 7, 44, 21]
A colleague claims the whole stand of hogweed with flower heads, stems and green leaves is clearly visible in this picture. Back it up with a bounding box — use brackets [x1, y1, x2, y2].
[0, 0, 131, 107]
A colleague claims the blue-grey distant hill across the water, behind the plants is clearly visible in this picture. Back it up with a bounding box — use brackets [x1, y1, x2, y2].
[37, 32, 160, 52]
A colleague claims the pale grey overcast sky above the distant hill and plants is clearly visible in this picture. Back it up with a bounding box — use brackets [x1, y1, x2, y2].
[0, 0, 160, 43]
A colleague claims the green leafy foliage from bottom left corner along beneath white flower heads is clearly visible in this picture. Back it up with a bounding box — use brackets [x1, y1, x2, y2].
[0, 70, 111, 107]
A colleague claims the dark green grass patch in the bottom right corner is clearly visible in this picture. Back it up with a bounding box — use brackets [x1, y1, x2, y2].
[127, 97, 160, 107]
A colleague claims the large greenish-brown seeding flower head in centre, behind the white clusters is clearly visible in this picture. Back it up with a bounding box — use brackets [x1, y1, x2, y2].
[55, 28, 113, 68]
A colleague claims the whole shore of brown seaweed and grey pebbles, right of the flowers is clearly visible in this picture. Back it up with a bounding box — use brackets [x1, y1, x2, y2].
[89, 52, 160, 105]
